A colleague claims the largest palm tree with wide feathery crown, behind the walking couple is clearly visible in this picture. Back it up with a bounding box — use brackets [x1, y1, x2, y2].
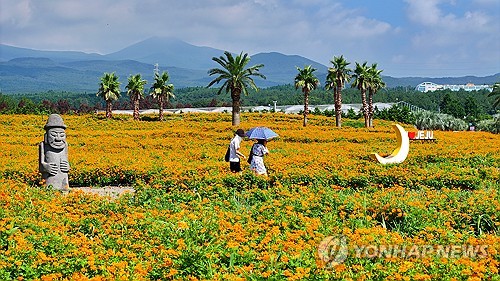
[207, 51, 266, 126]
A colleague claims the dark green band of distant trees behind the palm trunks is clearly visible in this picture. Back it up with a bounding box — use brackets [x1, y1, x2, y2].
[0, 84, 496, 120]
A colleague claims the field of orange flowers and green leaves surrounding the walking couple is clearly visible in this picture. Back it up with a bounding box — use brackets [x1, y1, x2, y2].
[0, 113, 500, 280]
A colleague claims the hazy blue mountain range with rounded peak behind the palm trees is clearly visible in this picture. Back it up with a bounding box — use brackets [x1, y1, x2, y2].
[0, 37, 500, 94]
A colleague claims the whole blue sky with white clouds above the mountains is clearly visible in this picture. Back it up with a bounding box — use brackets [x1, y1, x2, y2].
[0, 0, 500, 77]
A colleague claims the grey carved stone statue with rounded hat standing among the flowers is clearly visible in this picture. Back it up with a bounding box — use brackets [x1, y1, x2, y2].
[38, 114, 70, 191]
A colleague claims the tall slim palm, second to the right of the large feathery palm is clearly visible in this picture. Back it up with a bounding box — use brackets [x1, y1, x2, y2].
[325, 55, 351, 128]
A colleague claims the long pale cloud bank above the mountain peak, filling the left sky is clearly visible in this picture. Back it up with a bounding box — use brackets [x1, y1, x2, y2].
[0, 0, 390, 55]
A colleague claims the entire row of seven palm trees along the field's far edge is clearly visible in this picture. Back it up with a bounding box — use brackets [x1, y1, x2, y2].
[93, 51, 385, 127]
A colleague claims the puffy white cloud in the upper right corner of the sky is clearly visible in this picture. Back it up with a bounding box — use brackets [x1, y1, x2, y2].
[406, 0, 500, 68]
